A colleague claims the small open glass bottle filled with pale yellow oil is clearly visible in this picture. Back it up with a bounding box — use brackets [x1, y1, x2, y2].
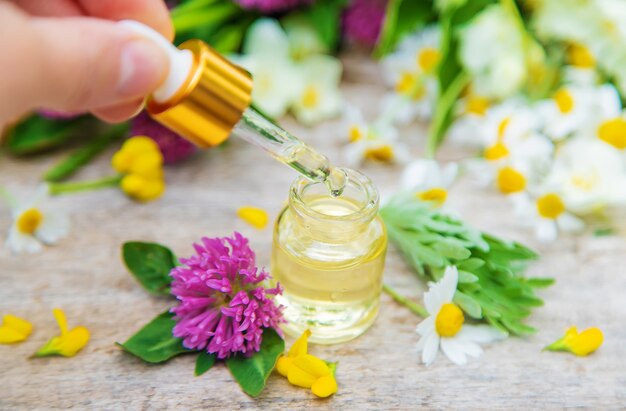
[271, 169, 387, 344]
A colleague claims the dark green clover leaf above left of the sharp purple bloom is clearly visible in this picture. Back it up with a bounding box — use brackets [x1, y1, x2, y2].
[122, 242, 177, 295]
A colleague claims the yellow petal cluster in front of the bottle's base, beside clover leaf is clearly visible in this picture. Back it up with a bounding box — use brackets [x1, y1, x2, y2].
[276, 330, 337, 398]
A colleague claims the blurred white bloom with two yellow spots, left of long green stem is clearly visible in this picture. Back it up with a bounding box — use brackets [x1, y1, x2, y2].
[381, 26, 441, 124]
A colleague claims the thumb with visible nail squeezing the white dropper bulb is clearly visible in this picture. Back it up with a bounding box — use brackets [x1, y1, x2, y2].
[0, 5, 168, 120]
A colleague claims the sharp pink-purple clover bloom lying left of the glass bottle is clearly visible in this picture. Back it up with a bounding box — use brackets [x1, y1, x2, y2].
[170, 232, 284, 359]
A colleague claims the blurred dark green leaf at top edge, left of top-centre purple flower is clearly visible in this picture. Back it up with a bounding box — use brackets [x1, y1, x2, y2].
[302, 0, 347, 50]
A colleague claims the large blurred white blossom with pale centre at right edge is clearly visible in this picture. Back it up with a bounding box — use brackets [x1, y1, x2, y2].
[546, 137, 626, 214]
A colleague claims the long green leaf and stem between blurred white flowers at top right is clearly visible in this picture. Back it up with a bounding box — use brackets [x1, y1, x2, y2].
[427, 0, 496, 157]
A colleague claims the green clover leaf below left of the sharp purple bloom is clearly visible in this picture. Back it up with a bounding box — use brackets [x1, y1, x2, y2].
[118, 311, 193, 364]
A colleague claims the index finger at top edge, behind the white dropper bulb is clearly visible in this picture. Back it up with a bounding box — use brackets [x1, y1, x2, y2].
[76, 0, 174, 41]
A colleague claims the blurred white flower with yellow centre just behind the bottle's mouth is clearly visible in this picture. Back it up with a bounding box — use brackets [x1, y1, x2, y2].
[340, 106, 409, 167]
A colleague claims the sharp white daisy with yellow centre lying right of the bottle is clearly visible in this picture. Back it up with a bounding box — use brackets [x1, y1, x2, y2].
[417, 266, 507, 365]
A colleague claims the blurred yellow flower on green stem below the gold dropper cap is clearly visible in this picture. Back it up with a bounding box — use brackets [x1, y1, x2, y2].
[111, 136, 165, 201]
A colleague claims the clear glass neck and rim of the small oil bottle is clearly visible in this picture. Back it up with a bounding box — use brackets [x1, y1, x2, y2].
[289, 169, 379, 242]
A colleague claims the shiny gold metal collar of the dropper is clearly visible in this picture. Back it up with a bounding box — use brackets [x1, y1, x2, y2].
[146, 40, 252, 148]
